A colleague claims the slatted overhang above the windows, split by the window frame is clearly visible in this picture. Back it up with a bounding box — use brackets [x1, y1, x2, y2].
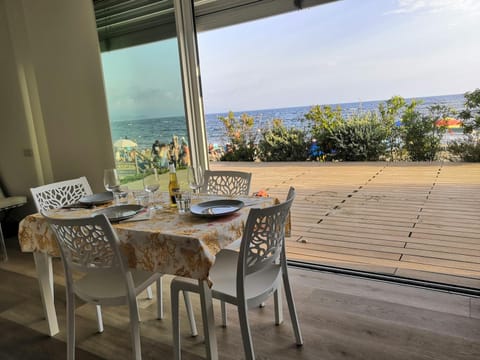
[93, 0, 335, 51]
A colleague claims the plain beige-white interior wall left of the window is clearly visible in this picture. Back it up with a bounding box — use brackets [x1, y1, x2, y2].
[0, 0, 114, 217]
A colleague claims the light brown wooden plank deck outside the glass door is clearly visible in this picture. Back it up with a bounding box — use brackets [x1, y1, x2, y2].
[211, 162, 480, 288]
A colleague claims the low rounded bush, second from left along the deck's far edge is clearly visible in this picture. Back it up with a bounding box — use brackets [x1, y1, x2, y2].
[258, 119, 308, 161]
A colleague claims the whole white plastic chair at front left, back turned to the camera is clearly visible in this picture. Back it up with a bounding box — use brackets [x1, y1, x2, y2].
[43, 213, 162, 360]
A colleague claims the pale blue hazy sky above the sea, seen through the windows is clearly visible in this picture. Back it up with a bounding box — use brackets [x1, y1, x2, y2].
[102, 0, 480, 120]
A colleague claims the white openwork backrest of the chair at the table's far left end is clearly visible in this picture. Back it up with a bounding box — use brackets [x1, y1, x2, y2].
[30, 176, 92, 212]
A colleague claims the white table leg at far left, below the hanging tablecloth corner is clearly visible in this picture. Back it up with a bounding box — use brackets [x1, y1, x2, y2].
[33, 252, 59, 336]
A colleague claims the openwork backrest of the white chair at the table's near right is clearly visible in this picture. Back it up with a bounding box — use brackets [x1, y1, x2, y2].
[237, 187, 295, 280]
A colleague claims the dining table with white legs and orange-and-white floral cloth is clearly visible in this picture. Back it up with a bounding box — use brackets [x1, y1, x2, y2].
[18, 193, 278, 359]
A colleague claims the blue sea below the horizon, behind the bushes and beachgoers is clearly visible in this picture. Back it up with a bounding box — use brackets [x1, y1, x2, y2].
[110, 94, 465, 149]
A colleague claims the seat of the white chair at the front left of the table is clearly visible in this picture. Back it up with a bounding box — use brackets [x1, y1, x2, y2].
[75, 270, 162, 305]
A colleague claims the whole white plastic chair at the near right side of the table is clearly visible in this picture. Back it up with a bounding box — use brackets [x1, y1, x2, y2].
[170, 188, 303, 360]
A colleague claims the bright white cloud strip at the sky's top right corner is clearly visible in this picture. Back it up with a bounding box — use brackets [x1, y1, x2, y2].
[386, 0, 480, 14]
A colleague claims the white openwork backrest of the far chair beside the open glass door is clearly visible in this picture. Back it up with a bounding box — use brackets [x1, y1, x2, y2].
[201, 170, 252, 195]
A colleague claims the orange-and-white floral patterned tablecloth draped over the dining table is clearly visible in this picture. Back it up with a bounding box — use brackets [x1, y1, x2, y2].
[18, 197, 278, 280]
